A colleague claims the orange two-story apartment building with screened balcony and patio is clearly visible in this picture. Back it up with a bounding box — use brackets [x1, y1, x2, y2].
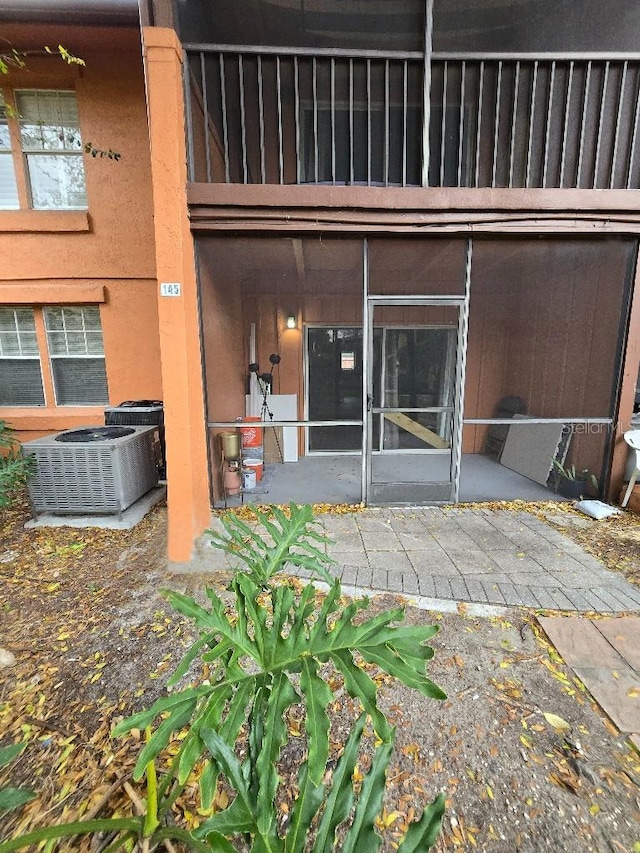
[0, 0, 640, 562]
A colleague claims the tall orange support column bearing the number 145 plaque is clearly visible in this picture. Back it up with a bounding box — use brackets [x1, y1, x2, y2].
[142, 27, 210, 562]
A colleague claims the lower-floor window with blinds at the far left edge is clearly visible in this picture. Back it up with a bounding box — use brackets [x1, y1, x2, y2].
[0, 308, 45, 406]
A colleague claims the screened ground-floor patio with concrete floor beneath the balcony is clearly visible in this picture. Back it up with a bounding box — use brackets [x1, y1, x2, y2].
[197, 233, 636, 505]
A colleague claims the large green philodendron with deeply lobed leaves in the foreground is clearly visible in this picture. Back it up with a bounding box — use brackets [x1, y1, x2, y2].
[0, 504, 445, 853]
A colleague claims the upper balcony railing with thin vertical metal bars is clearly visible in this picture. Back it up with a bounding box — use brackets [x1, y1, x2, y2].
[186, 46, 640, 189]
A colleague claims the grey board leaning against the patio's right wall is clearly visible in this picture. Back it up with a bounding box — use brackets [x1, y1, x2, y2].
[500, 416, 564, 486]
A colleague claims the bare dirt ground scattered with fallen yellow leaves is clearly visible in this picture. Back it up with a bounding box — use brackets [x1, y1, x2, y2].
[0, 496, 640, 853]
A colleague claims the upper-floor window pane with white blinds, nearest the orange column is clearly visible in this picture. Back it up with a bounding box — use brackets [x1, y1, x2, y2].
[15, 89, 87, 210]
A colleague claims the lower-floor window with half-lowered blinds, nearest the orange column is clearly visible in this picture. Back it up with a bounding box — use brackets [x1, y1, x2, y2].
[44, 306, 109, 406]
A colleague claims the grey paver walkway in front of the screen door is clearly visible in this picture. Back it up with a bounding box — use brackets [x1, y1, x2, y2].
[304, 507, 640, 613]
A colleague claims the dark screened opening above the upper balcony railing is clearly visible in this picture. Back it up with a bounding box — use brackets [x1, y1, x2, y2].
[177, 0, 640, 52]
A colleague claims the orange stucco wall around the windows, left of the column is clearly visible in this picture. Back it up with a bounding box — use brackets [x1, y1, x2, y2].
[0, 24, 162, 440]
